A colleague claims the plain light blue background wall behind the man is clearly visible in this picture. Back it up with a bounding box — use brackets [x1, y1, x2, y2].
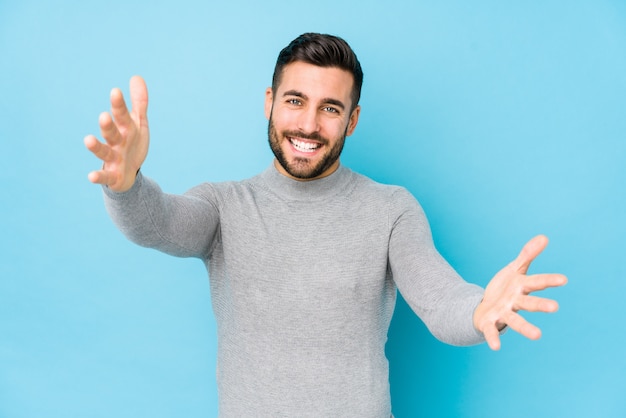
[0, 0, 626, 418]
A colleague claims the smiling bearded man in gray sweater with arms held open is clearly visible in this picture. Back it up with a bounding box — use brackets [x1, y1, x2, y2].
[85, 34, 566, 417]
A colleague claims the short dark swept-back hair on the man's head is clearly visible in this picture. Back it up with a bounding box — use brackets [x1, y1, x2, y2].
[272, 33, 363, 109]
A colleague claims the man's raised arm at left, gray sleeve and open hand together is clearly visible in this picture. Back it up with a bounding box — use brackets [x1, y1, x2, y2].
[85, 76, 219, 258]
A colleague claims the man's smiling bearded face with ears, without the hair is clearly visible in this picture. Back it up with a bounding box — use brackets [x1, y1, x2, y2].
[265, 61, 361, 180]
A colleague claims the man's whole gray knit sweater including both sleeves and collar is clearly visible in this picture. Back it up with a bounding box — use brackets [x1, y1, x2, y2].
[105, 166, 483, 417]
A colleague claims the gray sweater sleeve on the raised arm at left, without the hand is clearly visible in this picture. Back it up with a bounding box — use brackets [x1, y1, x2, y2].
[103, 173, 219, 258]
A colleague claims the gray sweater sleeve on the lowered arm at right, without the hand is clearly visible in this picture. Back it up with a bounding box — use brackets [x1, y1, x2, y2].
[389, 189, 484, 345]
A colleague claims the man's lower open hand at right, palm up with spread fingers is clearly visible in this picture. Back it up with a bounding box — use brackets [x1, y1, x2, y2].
[474, 235, 567, 350]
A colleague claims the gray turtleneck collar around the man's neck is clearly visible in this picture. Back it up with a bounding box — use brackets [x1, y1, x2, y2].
[260, 163, 352, 201]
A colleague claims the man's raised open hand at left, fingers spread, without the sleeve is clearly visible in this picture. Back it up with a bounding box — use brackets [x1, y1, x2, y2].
[84, 76, 150, 192]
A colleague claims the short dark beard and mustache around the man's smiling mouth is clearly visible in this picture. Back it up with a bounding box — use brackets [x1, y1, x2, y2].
[267, 114, 348, 180]
